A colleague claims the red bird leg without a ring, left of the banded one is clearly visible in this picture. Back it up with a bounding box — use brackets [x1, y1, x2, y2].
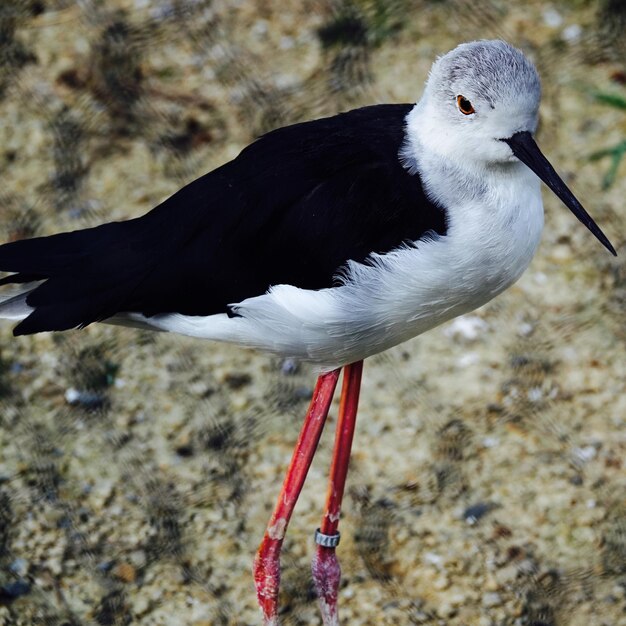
[253, 369, 340, 626]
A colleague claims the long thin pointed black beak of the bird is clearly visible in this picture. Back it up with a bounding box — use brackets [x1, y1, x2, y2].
[502, 131, 617, 256]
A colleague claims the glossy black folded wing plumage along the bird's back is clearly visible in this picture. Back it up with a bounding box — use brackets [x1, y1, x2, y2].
[0, 105, 446, 334]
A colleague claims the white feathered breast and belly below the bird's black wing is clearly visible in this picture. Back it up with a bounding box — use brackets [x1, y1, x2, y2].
[141, 164, 543, 369]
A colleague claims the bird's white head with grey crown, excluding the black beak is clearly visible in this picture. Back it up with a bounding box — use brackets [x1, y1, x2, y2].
[420, 41, 541, 167]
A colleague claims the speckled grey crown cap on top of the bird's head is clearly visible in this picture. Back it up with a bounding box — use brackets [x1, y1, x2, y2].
[428, 39, 541, 105]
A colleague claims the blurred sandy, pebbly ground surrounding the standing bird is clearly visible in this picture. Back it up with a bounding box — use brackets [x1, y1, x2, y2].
[0, 0, 626, 626]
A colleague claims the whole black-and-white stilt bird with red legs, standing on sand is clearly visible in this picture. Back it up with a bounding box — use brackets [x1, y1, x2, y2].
[0, 40, 616, 626]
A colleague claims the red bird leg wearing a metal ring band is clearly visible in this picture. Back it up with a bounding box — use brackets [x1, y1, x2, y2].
[311, 361, 363, 626]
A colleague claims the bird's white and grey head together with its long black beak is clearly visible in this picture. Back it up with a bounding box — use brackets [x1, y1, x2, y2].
[407, 40, 615, 254]
